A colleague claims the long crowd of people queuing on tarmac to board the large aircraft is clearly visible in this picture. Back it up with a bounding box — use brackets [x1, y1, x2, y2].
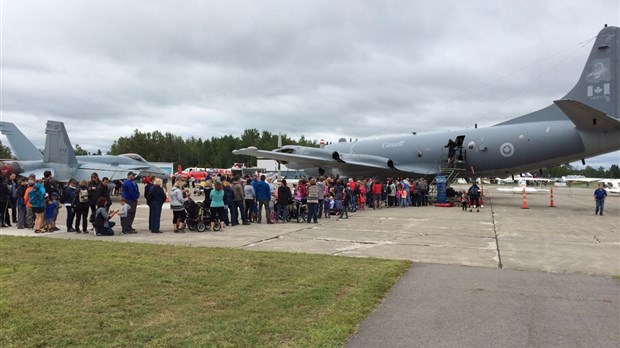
[0, 171, 605, 236]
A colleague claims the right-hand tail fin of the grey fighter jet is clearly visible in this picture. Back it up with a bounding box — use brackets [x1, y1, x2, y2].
[43, 121, 77, 165]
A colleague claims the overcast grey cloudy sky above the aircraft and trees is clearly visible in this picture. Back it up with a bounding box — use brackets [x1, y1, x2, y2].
[1, 0, 620, 167]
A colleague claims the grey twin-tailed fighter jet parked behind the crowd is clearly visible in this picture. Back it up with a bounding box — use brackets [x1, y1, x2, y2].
[0, 121, 168, 183]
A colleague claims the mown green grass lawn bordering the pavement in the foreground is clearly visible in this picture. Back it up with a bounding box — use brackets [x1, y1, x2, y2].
[0, 237, 410, 347]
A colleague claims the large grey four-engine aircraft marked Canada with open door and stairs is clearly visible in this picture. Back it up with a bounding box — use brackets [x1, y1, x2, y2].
[233, 26, 620, 177]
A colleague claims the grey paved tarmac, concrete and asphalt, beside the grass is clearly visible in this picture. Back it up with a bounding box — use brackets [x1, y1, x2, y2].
[0, 187, 620, 347]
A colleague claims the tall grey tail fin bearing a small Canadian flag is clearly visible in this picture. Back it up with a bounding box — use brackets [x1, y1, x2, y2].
[562, 27, 620, 118]
